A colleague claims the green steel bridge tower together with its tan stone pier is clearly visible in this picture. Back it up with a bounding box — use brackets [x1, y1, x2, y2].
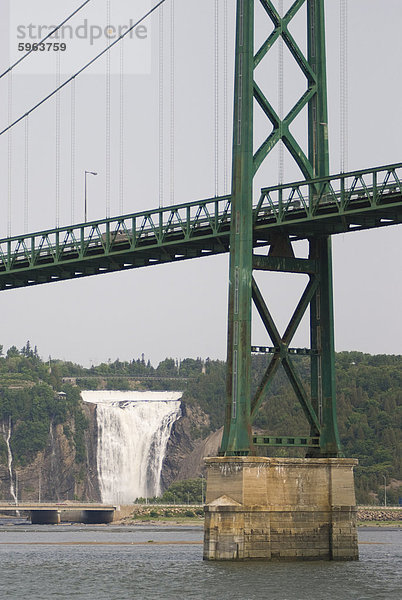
[204, 0, 358, 560]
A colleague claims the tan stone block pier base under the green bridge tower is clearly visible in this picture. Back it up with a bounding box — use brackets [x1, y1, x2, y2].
[204, 456, 358, 560]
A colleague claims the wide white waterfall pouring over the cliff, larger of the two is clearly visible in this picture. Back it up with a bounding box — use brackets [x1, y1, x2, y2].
[81, 390, 182, 504]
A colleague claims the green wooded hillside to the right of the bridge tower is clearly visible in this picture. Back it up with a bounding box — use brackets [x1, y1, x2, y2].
[336, 352, 402, 503]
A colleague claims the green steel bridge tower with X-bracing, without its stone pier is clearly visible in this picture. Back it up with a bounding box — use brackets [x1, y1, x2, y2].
[221, 0, 340, 457]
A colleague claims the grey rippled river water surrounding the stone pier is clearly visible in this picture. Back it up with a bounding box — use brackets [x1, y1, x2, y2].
[0, 521, 402, 600]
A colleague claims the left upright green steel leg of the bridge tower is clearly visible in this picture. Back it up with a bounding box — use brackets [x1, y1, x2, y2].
[222, 0, 254, 456]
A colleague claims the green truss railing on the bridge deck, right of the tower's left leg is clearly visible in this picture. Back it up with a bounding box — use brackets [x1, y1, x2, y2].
[254, 163, 402, 223]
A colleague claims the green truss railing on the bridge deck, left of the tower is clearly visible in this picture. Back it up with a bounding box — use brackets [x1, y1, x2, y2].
[0, 196, 230, 272]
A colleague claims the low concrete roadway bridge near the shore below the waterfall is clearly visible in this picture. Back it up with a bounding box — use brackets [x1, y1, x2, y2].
[0, 502, 117, 525]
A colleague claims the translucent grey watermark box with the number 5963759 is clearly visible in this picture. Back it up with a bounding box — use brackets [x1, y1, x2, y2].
[9, 0, 151, 75]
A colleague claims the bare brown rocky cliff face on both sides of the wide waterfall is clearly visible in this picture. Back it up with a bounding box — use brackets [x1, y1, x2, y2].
[0, 402, 221, 502]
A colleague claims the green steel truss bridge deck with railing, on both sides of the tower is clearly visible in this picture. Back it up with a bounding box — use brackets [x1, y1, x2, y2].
[0, 163, 402, 290]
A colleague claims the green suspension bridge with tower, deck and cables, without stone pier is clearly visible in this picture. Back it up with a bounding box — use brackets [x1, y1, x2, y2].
[0, 0, 402, 556]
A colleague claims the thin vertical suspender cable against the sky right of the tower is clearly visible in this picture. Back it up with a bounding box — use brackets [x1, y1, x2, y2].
[339, 0, 349, 173]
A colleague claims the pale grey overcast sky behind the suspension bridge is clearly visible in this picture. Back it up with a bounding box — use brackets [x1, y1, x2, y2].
[0, 0, 402, 366]
